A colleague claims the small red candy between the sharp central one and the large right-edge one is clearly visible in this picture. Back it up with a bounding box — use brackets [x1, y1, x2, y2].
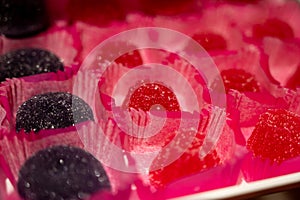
[221, 69, 260, 92]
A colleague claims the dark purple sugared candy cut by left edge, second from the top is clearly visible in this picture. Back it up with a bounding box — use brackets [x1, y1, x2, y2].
[0, 48, 64, 82]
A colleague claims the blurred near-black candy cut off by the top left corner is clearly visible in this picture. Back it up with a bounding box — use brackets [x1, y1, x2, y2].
[0, 0, 49, 38]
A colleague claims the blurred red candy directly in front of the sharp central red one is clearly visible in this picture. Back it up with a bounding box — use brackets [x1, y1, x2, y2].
[149, 108, 234, 189]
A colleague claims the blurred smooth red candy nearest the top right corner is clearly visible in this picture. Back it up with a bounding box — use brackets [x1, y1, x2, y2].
[253, 18, 294, 39]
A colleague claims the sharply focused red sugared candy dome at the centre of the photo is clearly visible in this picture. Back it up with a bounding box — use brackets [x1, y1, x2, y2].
[128, 83, 180, 111]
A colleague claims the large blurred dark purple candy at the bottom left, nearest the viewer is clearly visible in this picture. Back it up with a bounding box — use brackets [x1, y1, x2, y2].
[17, 146, 110, 200]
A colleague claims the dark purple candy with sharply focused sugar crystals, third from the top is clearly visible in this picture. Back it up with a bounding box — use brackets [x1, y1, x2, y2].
[16, 92, 94, 132]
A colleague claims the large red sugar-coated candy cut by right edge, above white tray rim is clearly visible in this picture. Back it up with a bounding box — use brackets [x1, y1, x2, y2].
[247, 109, 300, 163]
